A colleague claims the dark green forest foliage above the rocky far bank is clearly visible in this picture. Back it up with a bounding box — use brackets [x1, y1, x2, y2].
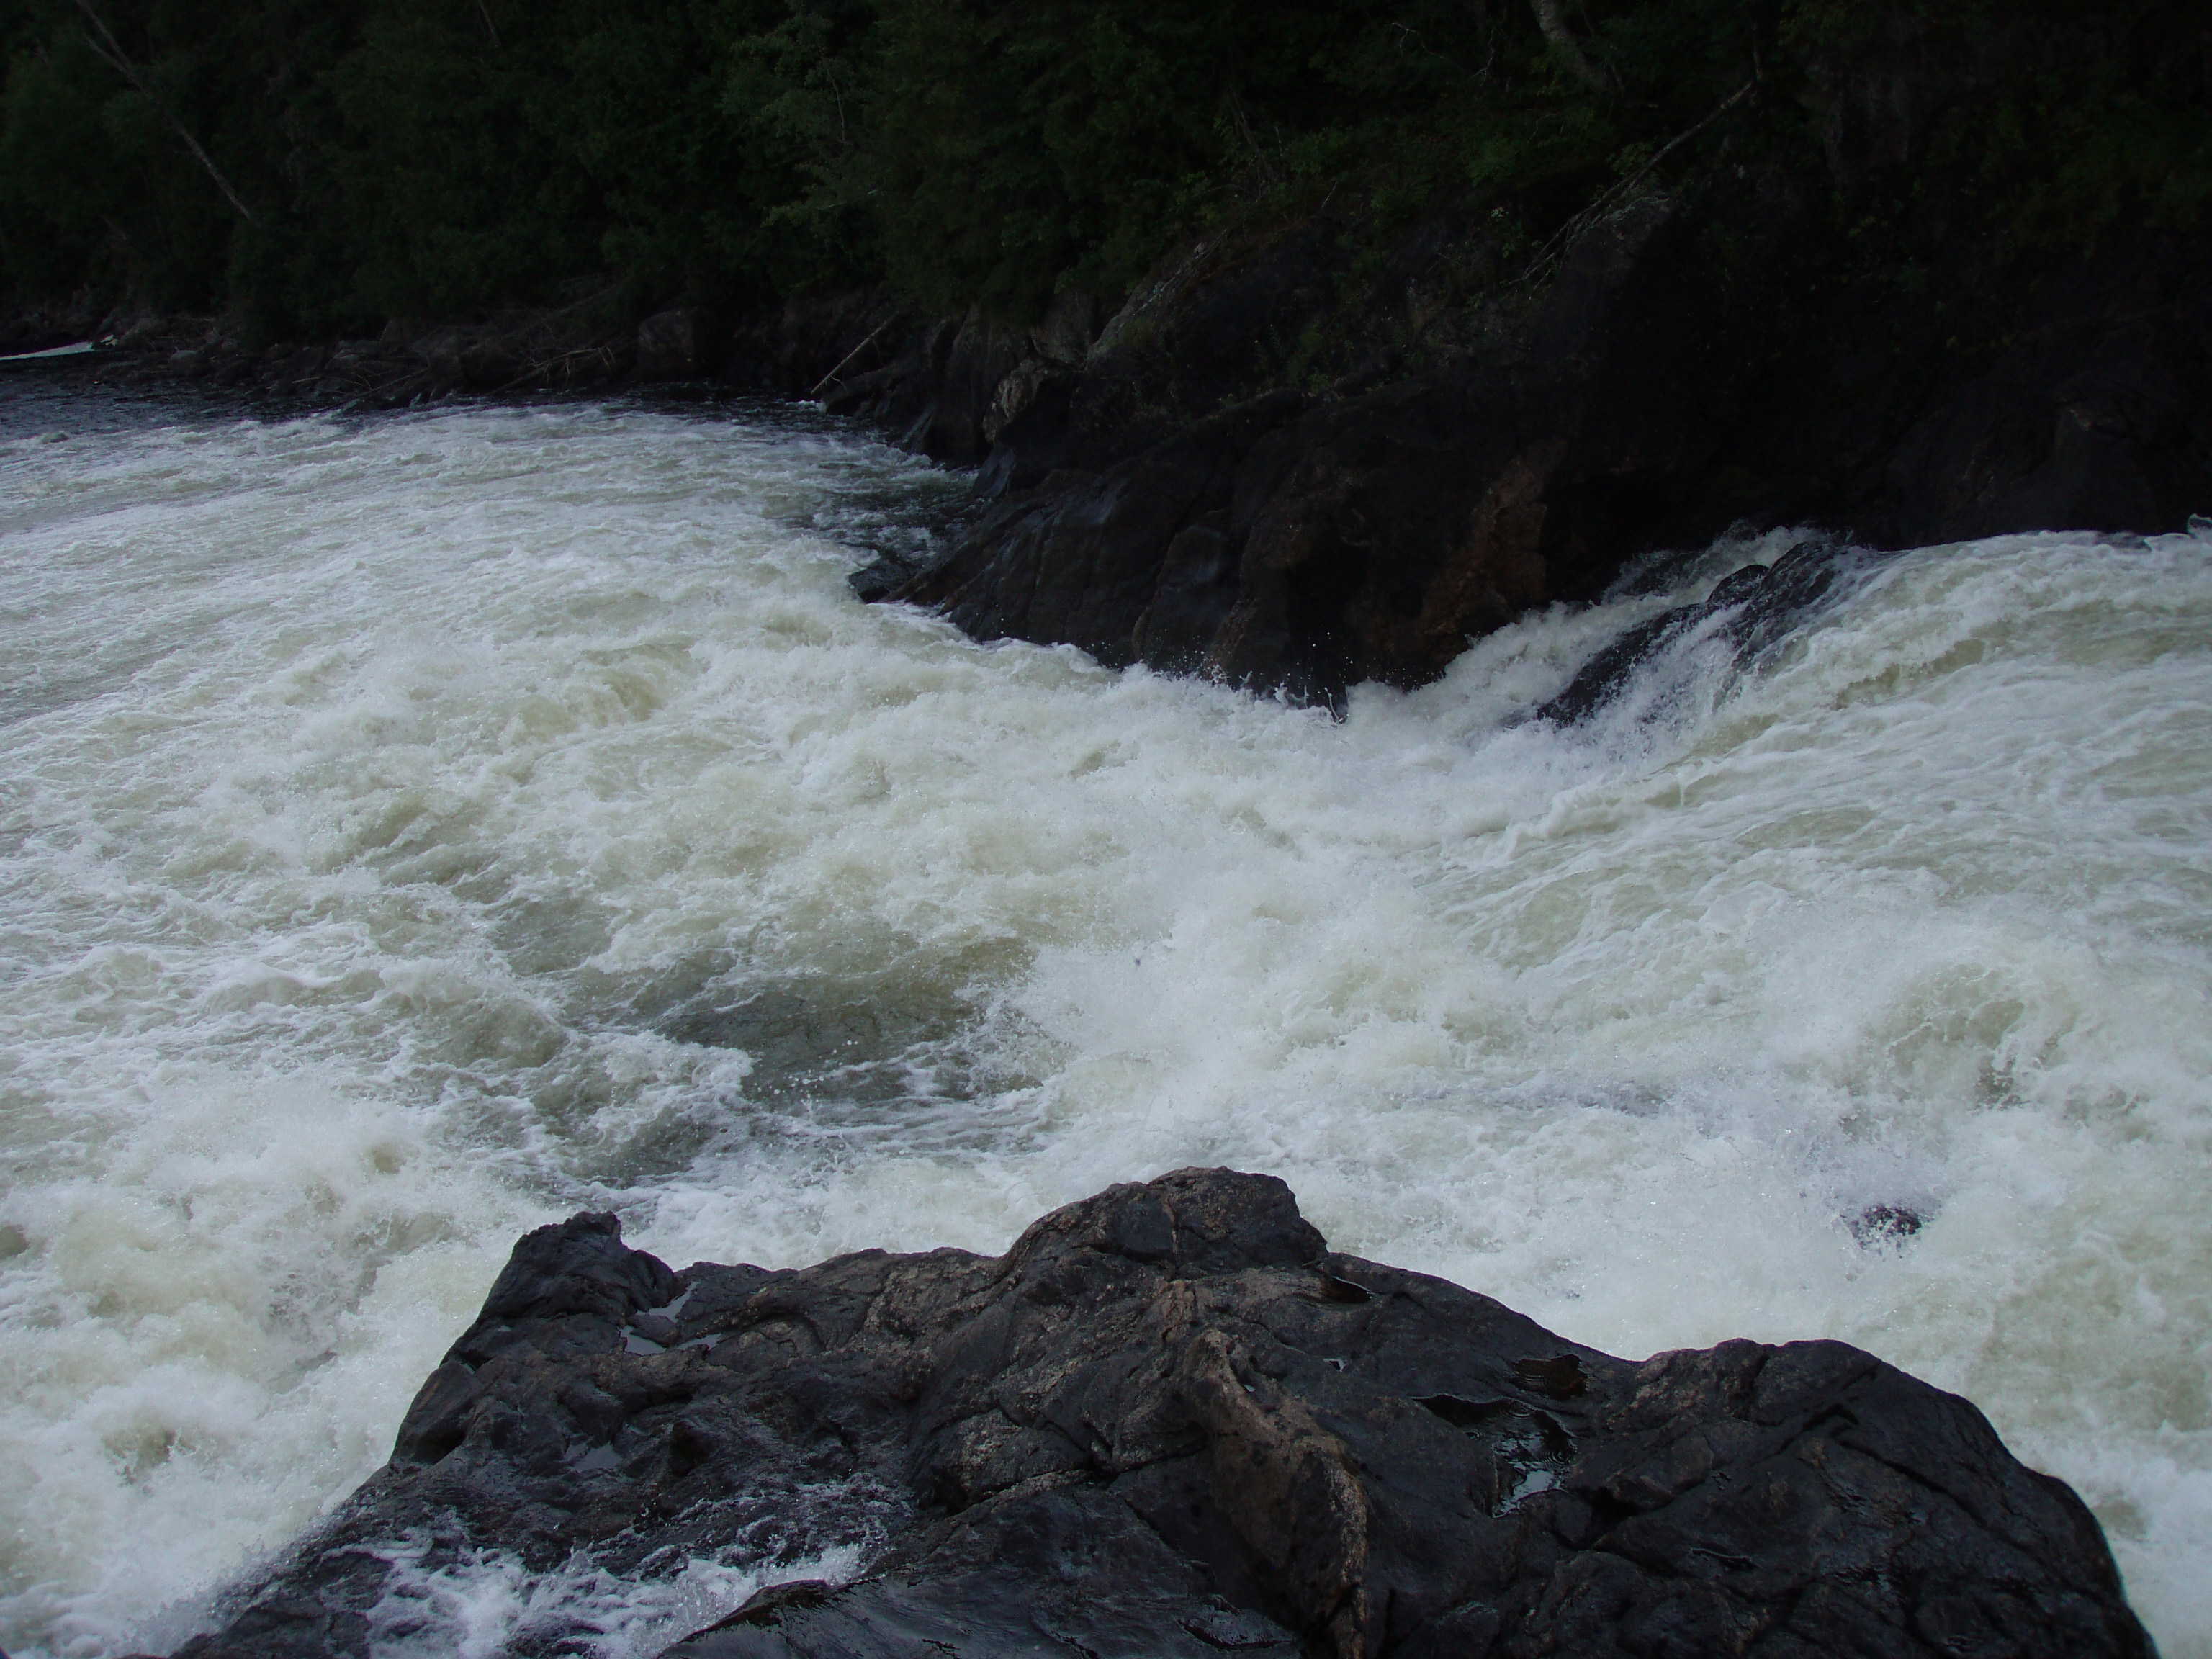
[0, 0, 2212, 332]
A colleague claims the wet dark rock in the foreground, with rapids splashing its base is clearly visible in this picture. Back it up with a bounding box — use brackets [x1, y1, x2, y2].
[163, 1170, 2150, 1659]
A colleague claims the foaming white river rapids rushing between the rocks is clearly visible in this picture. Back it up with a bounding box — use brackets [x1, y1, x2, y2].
[0, 400, 2212, 1659]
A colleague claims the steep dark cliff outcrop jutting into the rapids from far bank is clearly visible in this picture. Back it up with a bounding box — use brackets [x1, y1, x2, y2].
[788, 13, 2212, 701]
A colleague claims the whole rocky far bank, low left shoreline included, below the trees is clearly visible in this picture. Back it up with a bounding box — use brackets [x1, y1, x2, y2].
[21, 170, 2212, 721]
